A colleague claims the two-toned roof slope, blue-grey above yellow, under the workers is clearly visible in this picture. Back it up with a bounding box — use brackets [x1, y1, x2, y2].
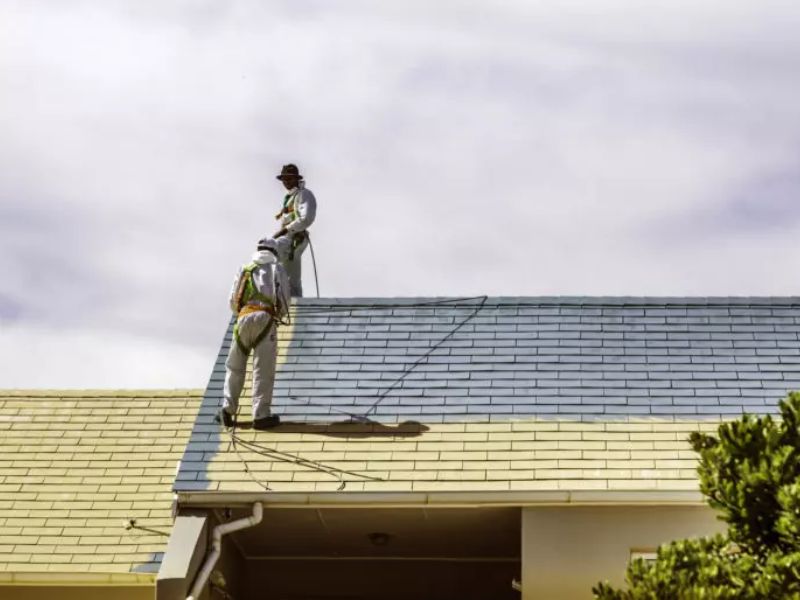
[176, 298, 800, 500]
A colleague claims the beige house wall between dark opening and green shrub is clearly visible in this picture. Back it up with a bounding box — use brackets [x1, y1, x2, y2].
[522, 506, 724, 600]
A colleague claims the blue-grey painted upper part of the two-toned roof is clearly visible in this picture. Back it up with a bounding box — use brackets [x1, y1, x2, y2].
[209, 298, 800, 422]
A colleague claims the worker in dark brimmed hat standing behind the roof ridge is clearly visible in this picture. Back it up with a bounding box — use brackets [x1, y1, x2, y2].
[273, 164, 317, 296]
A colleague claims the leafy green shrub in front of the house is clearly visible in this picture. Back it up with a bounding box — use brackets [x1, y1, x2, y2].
[592, 392, 800, 600]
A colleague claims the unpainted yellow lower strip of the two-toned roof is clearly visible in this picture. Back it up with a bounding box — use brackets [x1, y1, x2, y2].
[186, 407, 718, 493]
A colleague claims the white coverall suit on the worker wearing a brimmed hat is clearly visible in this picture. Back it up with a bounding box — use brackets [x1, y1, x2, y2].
[275, 181, 317, 297]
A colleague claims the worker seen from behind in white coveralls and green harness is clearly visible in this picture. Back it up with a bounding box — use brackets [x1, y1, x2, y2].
[217, 240, 291, 429]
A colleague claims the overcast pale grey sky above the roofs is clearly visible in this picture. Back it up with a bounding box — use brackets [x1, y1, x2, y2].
[0, 0, 800, 388]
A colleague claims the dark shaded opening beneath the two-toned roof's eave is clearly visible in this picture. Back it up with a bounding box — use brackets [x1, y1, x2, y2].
[228, 507, 521, 600]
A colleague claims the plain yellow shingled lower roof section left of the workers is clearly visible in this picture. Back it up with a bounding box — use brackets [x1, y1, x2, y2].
[0, 390, 201, 580]
